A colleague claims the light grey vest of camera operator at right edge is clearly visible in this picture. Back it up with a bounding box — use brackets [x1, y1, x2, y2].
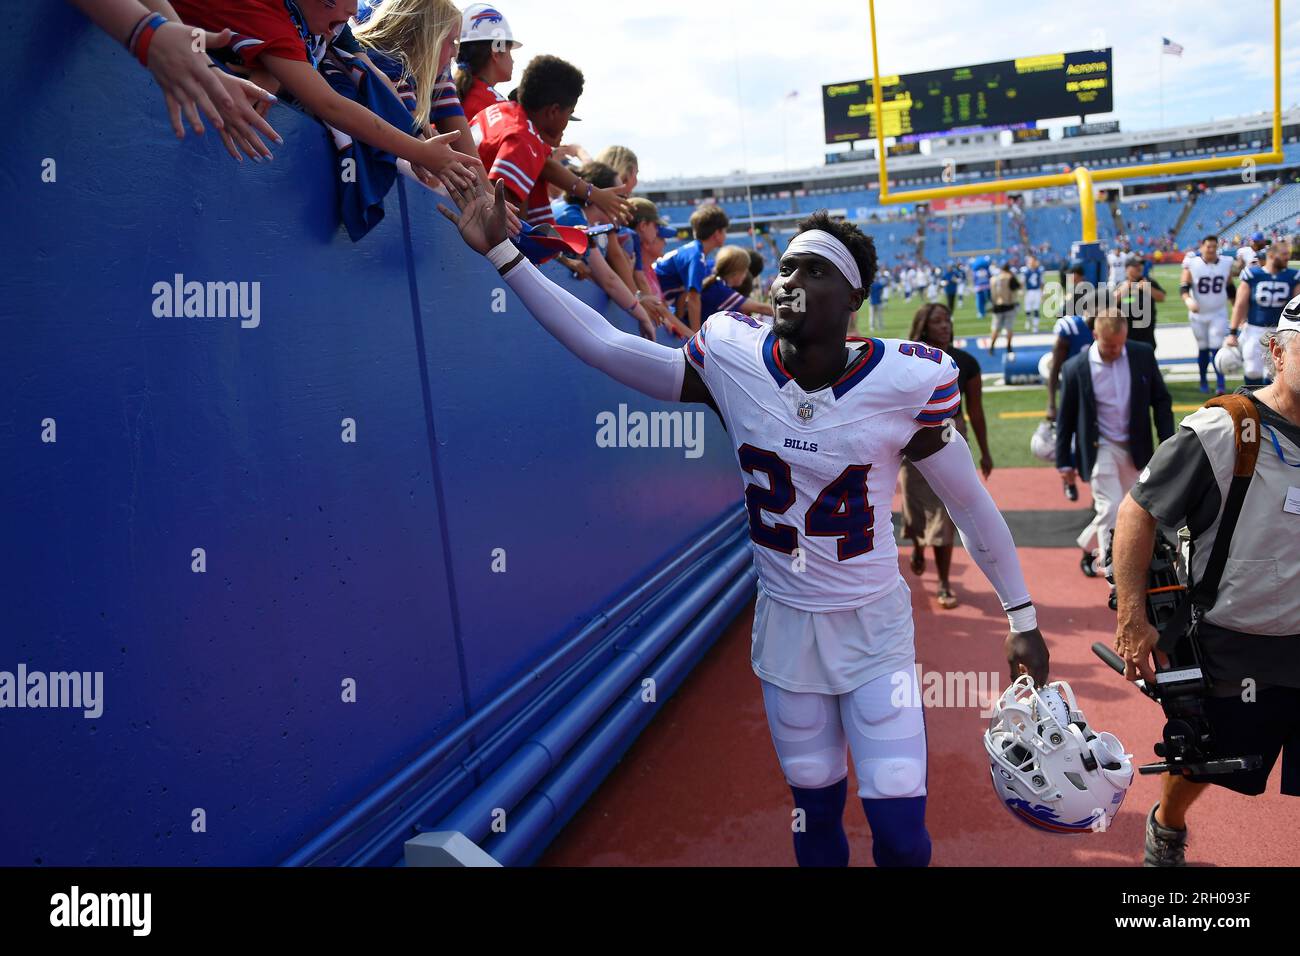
[1182, 408, 1300, 636]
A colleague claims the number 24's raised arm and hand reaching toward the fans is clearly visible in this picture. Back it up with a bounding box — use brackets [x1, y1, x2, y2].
[438, 179, 692, 402]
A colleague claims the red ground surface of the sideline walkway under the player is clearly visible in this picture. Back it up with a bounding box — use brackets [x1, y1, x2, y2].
[541, 468, 1300, 866]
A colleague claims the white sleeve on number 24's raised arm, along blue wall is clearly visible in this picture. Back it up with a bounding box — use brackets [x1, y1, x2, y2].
[488, 239, 686, 402]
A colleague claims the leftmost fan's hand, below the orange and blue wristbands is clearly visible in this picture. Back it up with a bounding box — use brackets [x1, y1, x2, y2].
[148, 22, 235, 139]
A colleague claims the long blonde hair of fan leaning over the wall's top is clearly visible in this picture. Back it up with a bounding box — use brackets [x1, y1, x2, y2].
[352, 0, 460, 131]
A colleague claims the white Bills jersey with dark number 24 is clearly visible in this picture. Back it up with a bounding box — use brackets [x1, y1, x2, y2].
[684, 312, 961, 611]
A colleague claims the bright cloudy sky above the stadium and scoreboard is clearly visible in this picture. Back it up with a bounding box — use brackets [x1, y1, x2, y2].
[499, 0, 1300, 179]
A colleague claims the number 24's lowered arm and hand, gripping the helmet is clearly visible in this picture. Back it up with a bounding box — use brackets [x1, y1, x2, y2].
[904, 425, 1048, 684]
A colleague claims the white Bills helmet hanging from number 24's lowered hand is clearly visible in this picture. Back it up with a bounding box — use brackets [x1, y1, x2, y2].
[984, 674, 1134, 834]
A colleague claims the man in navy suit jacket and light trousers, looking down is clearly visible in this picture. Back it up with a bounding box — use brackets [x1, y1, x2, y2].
[1057, 308, 1174, 587]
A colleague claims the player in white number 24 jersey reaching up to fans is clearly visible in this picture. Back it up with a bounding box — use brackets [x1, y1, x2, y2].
[439, 181, 1048, 866]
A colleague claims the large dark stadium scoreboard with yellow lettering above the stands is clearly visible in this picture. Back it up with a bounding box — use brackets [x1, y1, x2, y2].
[822, 47, 1114, 143]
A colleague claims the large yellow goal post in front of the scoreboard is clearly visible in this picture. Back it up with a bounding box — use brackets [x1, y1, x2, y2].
[868, 0, 1283, 243]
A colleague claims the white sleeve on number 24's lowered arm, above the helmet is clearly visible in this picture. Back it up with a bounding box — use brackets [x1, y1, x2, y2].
[913, 428, 1037, 631]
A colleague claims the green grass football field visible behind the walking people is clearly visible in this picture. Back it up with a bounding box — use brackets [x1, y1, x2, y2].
[858, 265, 1242, 468]
